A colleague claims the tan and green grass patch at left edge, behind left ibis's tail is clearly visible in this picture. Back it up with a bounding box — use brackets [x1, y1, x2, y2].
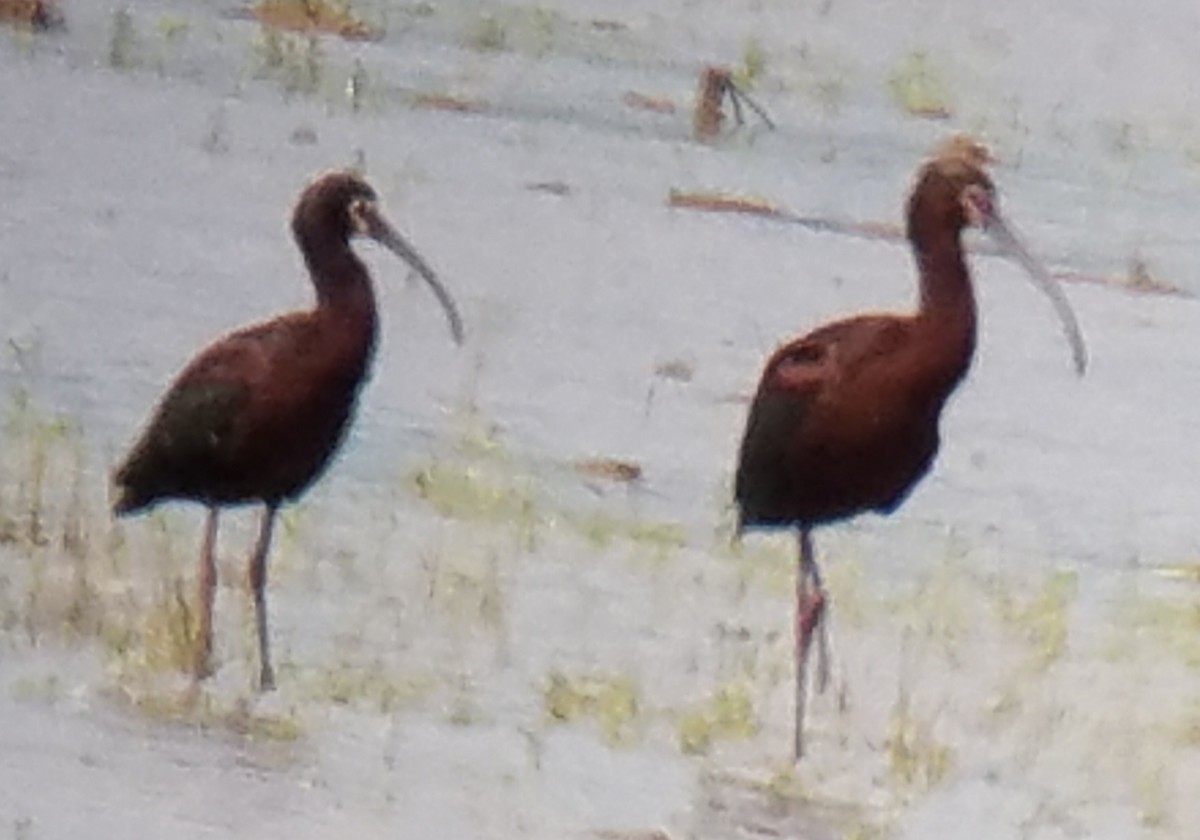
[0, 389, 220, 700]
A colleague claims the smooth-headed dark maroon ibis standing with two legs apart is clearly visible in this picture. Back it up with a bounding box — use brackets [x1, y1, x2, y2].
[114, 172, 462, 690]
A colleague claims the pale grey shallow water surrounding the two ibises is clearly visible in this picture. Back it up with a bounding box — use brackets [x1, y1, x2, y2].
[0, 0, 1200, 838]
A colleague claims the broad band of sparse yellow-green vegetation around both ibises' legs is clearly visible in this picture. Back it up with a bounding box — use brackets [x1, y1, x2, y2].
[0, 357, 1200, 840]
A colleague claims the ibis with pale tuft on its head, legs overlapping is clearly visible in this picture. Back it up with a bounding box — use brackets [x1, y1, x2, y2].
[734, 136, 1086, 758]
